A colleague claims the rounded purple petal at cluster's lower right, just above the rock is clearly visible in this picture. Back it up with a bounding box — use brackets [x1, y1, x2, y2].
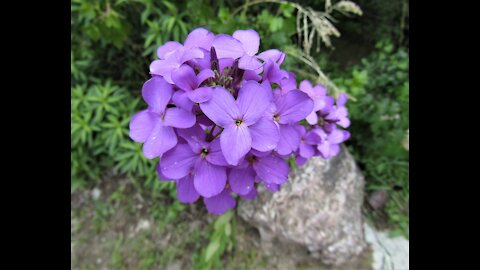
[253, 155, 290, 185]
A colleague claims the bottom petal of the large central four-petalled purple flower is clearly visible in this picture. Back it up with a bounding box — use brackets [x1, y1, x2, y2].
[220, 124, 252, 166]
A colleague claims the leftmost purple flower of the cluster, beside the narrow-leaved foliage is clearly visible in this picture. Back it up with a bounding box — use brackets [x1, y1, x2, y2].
[129, 77, 195, 159]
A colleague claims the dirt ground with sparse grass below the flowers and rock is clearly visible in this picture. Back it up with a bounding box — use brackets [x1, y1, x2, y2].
[71, 175, 371, 270]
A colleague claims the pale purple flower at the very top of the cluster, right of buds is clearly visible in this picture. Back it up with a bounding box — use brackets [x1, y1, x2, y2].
[213, 30, 263, 70]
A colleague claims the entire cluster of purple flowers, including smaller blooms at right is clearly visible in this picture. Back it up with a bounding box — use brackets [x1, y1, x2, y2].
[130, 28, 350, 215]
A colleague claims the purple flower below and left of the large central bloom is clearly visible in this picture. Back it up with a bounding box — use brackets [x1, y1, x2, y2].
[158, 125, 227, 198]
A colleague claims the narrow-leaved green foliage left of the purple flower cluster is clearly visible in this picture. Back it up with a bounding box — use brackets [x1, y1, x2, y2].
[71, 80, 163, 195]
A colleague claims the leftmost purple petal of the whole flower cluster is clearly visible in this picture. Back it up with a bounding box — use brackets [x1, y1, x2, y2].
[129, 110, 160, 143]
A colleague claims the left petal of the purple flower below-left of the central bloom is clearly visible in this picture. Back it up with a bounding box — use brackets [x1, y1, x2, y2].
[159, 144, 200, 179]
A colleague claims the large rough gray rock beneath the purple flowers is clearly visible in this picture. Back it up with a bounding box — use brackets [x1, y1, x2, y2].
[238, 148, 367, 266]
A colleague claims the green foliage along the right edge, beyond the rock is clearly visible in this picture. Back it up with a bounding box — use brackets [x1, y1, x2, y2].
[337, 41, 409, 236]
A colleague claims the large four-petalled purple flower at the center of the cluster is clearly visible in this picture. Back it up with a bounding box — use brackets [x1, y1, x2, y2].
[200, 81, 278, 165]
